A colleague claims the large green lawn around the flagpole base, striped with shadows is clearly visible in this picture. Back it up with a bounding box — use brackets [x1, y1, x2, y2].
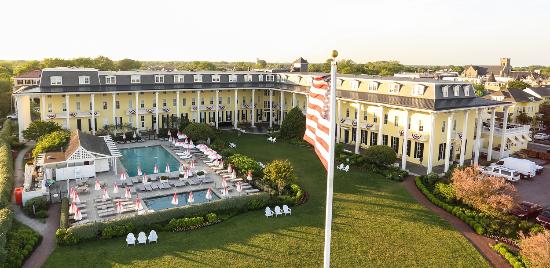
[46, 135, 488, 267]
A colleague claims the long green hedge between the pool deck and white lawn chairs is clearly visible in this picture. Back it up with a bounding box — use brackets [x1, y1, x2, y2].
[56, 193, 273, 245]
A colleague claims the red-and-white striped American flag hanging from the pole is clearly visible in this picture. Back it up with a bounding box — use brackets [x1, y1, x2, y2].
[304, 76, 331, 170]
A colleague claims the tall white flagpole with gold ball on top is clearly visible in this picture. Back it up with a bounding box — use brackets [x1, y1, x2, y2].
[323, 50, 338, 268]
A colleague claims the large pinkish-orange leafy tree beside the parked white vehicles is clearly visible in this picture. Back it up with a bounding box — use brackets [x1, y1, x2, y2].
[452, 167, 518, 217]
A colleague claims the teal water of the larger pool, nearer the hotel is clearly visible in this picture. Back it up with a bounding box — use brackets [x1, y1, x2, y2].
[120, 145, 180, 177]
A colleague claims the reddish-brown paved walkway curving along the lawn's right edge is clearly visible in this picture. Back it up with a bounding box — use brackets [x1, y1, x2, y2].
[403, 176, 510, 268]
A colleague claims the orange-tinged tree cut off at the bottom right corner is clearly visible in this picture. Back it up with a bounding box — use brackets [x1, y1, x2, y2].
[519, 230, 550, 268]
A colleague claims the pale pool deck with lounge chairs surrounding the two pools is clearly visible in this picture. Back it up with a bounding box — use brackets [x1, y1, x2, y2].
[60, 140, 253, 224]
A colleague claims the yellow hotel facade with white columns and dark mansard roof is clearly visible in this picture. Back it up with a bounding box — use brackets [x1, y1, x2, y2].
[14, 68, 528, 173]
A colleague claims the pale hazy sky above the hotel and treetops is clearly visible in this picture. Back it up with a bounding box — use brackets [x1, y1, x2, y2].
[0, 0, 550, 66]
